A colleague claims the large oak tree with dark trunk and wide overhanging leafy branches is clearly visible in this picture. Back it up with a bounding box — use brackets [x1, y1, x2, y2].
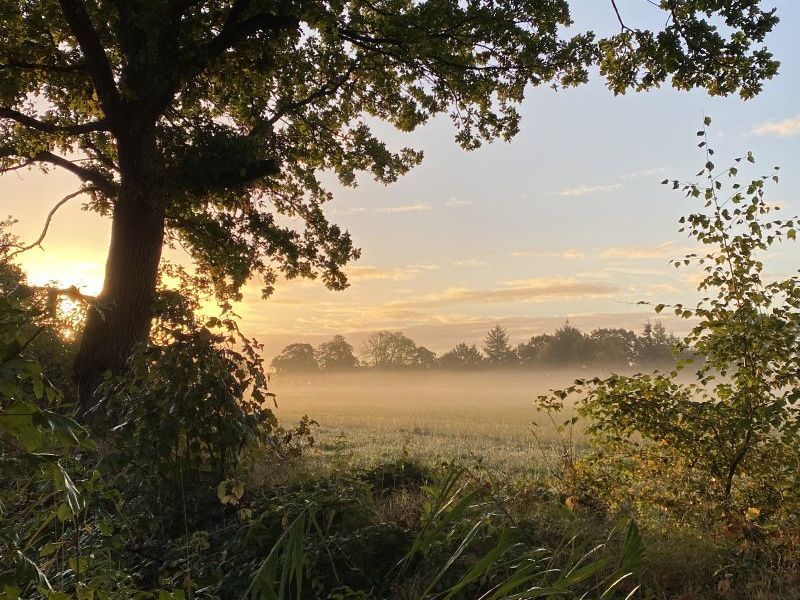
[0, 0, 778, 407]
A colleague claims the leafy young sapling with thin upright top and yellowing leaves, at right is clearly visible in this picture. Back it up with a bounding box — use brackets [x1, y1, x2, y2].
[538, 118, 800, 520]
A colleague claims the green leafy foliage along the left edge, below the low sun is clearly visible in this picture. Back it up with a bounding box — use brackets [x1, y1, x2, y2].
[0, 257, 101, 599]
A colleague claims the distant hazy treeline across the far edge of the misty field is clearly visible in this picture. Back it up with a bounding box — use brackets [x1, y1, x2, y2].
[272, 322, 676, 373]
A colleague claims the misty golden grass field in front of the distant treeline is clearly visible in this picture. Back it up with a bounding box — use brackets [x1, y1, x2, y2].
[271, 369, 599, 470]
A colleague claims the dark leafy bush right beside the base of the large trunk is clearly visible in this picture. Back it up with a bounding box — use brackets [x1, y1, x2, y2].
[95, 266, 291, 480]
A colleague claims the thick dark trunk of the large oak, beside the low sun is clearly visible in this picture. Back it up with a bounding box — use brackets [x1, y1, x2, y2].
[73, 135, 164, 418]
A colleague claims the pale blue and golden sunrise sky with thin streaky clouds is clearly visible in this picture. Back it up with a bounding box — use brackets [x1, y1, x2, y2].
[0, 0, 800, 355]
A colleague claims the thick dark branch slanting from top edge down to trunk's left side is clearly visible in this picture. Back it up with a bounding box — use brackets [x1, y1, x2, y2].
[59, 0, 123, 125]
